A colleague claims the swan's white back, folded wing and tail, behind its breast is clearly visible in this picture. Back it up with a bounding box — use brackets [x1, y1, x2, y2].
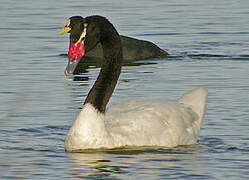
[105, 88, 207, 147]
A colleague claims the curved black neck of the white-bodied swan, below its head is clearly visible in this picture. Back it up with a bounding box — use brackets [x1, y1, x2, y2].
[84, 18, 123, 113]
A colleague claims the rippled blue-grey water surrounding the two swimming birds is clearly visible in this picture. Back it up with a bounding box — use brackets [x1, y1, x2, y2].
[0, 0, 249, 179]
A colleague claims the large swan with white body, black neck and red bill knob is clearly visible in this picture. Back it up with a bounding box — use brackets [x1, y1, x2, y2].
[61, 16, 207, 152]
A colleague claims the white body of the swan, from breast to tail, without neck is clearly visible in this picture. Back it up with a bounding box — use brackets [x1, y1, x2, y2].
[65, 88, 207, 151]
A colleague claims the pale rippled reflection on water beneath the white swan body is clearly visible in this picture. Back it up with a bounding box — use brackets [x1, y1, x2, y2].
[68, 145, 208, 179]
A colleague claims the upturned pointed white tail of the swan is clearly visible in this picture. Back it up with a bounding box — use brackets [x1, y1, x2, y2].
[178, 88, 208, 124]
